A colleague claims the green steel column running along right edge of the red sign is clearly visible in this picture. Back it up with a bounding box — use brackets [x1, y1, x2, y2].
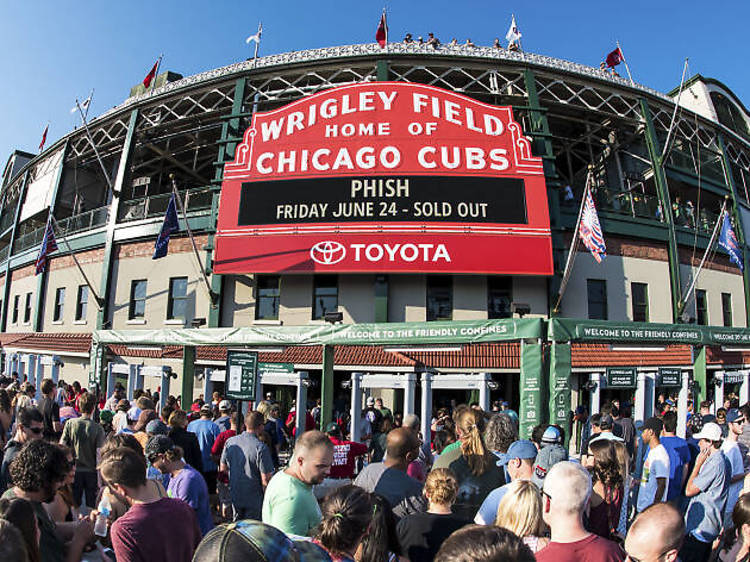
[523, 69, 566, 315]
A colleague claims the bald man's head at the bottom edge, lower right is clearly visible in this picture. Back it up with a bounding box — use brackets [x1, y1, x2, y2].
[625, 503, 685, 562]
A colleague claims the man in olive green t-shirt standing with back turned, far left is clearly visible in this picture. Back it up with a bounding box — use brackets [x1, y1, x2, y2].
[60, 392, 105, 509]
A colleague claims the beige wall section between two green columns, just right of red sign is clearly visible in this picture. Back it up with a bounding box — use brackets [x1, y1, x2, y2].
[560, 252, 672, 322]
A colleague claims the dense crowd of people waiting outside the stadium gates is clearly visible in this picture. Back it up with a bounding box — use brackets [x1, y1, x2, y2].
[0, 370, 750, 562]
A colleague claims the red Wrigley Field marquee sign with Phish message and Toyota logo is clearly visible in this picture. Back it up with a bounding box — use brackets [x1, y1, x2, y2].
[214, 82, 552, 275]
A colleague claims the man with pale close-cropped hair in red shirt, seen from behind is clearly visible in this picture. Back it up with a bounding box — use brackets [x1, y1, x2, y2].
[536, 461, 625, 562]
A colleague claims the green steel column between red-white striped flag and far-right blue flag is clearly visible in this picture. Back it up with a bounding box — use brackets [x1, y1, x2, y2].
[640, 98, 682, 322]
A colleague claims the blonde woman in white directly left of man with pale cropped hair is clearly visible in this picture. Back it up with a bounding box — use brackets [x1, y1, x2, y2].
[495, 480, 549, 552]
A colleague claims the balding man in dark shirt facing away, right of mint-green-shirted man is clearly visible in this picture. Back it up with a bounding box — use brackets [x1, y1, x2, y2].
[354, 427, 427, 518]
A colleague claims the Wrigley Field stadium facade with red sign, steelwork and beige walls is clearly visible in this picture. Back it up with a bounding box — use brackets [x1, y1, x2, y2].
[0, 44, 750, 438]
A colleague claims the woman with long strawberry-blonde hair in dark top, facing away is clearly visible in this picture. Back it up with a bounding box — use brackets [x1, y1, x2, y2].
[434, 409, 505, 519]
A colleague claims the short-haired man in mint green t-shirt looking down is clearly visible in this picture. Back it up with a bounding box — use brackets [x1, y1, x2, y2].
[263, 430, 333, 536]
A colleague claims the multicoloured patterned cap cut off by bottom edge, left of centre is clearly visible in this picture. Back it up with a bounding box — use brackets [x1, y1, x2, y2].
[193, 519, 331, 562]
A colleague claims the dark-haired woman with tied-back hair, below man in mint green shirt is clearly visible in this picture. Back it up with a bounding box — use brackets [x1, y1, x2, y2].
[315, 485, 372, 562]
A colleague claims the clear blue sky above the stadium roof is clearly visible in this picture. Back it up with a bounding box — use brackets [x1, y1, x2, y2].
[0, 0, 750, 166]
